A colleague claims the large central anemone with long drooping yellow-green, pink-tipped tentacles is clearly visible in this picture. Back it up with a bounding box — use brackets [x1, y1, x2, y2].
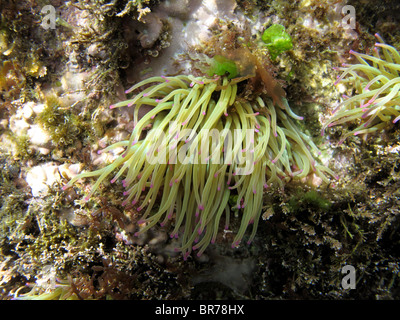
[64, 67, 333, 259]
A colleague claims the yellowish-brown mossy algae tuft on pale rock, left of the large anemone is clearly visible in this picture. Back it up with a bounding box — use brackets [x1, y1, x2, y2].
[35, 95, 88, 147]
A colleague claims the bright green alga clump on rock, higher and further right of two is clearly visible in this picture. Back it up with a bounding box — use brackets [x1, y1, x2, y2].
[261, 24, 293, 60]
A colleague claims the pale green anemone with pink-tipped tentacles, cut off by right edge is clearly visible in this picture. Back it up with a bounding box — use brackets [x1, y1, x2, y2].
[322, 34, 400, 143]
